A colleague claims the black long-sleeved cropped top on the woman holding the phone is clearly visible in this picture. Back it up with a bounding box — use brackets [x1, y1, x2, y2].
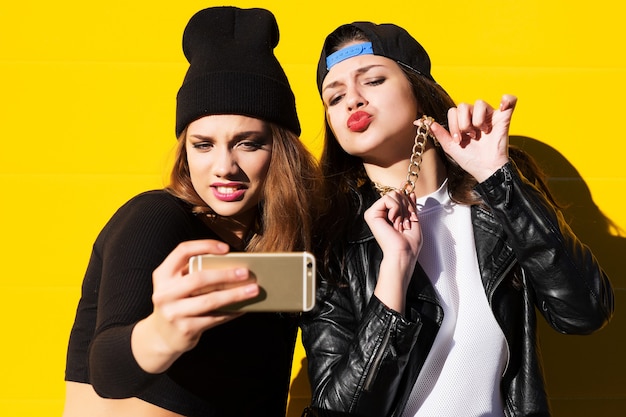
[65, 190, 297, 417]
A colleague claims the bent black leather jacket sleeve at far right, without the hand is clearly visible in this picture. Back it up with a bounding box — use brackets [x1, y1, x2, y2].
[477, 162, 614, 334]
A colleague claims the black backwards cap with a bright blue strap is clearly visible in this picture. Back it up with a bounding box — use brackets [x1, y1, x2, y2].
[317, 22, 435, 94]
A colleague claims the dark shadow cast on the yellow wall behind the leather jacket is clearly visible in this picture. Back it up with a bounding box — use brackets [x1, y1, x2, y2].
[287, 136, 626, 417]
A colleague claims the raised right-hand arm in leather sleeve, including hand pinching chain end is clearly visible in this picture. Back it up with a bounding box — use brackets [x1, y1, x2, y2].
[431, 95, 613, 334]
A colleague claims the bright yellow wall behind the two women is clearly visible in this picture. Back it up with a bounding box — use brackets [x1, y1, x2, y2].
[0, 0, 626, 417]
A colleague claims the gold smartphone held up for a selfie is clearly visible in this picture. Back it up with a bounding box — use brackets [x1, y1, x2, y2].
[189, 252, 315, 312]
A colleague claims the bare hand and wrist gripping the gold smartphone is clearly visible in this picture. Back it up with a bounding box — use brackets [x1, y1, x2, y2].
[131, 240, 259, 373]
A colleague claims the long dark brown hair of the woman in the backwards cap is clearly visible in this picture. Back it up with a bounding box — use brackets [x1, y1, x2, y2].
[317, 26, 557, 277]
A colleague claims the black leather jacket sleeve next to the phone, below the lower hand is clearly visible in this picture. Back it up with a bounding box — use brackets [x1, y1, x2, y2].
[302, 276, 421, 417]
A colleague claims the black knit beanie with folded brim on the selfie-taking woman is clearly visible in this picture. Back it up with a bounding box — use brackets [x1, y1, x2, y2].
[176, 7, 300, 137]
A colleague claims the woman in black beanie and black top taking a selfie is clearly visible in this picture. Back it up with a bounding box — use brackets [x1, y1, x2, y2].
[64, 7, 319, 417]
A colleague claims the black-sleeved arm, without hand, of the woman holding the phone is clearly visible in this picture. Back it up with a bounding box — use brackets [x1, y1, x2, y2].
[89, 194, 189, 398]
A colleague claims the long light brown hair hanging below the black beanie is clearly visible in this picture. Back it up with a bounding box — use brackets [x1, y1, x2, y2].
[167, 122, 321, 252]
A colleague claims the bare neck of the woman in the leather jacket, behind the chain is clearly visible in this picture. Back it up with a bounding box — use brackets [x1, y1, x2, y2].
[363, 145, 446, 197]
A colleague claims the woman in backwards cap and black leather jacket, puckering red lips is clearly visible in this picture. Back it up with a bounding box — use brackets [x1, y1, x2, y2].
[302, 22, 613, 417]
